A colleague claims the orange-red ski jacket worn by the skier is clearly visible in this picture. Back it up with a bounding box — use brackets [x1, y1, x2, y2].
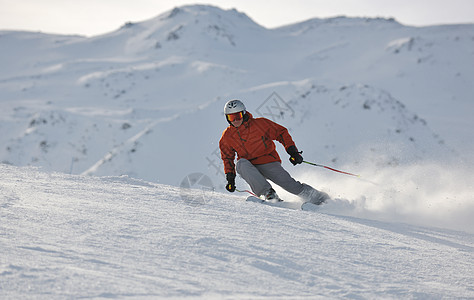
[219, 112, 295, 174]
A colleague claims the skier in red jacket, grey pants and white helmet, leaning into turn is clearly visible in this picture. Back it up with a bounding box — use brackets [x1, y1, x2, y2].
[219, 100, 329, 205]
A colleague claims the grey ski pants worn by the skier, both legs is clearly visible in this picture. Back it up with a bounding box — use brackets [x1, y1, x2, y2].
[235, 158, 303, 196]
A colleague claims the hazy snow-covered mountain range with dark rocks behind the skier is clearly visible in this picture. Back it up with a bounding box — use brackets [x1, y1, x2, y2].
[0, 5, 474, 189]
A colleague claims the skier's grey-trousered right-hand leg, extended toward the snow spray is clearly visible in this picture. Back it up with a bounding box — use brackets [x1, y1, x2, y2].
[256, 162, 303, 195]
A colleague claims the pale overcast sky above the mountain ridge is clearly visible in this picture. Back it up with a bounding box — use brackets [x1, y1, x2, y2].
[0, 0, 474, 36]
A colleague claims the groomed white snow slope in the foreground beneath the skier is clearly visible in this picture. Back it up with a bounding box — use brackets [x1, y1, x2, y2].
[0, 165, 474, 299]
